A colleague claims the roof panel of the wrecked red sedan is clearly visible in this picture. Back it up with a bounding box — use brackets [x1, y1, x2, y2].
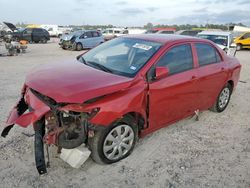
[121, 34, 207, 44]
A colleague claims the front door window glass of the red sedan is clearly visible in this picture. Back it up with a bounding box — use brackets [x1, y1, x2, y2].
[157, 44, 193, 75]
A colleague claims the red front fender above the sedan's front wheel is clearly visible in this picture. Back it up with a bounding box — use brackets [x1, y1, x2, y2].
[59, 79, 147, 129]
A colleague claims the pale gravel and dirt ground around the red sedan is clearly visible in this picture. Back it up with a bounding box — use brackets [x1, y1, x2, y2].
[0, 43, 250, 188]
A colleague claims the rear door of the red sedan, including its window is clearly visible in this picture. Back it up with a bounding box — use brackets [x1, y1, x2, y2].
[195, 43, 227, 110]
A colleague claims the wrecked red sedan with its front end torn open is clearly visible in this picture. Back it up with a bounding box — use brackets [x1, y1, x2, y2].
[2, 34, 241, 173]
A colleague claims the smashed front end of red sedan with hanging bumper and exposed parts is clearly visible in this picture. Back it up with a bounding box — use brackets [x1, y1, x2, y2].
[1, 86, 99, 174]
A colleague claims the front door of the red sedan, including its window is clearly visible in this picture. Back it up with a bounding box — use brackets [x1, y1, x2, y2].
[149, 43, 197, 129]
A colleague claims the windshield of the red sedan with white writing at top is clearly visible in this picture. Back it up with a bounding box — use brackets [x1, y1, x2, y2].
[79, 38, 161, 77]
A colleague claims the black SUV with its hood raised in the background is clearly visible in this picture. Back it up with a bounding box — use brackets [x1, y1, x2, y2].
[4, 22, 50, 43]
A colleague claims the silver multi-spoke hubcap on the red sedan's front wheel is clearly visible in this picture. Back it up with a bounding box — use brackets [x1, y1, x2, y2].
[103, 125, 135, 160]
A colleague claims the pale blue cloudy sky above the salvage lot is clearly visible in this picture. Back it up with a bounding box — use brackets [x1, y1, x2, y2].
[0, 0, 250, 27]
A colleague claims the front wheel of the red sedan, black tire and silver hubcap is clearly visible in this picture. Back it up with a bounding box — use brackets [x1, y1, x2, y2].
[88, 119, 138, 164]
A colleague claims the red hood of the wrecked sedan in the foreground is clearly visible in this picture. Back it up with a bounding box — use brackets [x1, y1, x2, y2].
[25, 60, 132, 103]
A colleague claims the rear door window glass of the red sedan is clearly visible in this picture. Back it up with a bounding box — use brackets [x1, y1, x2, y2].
[195, 43, 221, 66]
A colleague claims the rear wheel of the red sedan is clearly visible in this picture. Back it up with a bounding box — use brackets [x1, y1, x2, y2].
[210, 83, 233, 113]
